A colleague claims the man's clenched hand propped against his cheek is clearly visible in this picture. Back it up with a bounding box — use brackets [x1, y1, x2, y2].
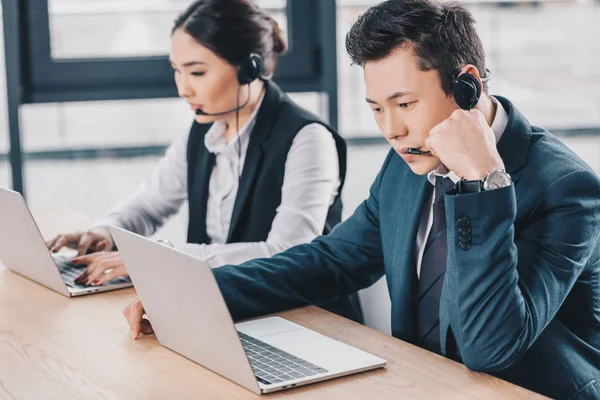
[425, 109, 504, 180]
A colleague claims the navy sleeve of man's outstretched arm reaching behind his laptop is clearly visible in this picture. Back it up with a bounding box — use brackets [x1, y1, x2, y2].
[213, 152, 391, 319]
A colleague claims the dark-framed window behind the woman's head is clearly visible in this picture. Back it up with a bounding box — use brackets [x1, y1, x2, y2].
[24, 0, 319, 103]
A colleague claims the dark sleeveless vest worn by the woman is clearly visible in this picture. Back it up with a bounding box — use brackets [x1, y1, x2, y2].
[187, 82, 362, 321]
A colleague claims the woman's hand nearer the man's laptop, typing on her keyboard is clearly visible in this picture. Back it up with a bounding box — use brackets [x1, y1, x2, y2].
[71, 251, 129, 285]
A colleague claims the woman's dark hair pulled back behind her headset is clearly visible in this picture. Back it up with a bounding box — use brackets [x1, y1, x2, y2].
[173, 0, 287, 74]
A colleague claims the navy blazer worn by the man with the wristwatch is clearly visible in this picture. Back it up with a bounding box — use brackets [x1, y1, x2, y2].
[214, 97, 600, 399]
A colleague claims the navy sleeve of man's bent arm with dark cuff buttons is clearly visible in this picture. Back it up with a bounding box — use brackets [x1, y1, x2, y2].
[442, 170, 600, 372]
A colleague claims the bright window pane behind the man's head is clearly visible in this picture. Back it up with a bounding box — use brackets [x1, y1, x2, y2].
[337, 0, 600, 137]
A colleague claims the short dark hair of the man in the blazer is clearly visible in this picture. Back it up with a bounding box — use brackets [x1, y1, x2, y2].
[346, 0, 487, 95]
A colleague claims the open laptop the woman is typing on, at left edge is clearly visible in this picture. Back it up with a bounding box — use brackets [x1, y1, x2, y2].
[0, 187, 133, 297]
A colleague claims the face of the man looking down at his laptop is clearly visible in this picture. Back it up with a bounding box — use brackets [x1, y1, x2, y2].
[364, 49, 458, 175]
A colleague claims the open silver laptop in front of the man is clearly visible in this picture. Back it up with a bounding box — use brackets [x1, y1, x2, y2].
[109, 227, 386, 394]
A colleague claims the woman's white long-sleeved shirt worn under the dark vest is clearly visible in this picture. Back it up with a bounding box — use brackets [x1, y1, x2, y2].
[97, 95, 340, 267]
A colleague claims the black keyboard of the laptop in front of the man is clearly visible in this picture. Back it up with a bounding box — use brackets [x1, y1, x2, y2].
[238, 332, 329, 385]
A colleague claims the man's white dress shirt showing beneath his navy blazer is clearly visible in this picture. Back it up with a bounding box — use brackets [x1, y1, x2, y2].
[415, 97, 508, 277]
